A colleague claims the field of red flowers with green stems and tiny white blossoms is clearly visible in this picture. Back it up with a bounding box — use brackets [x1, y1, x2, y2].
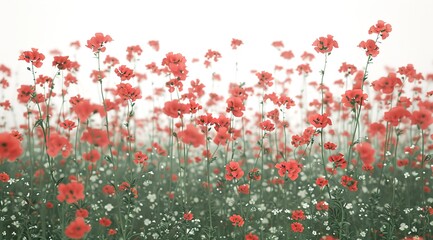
[0, 20, 433, 240]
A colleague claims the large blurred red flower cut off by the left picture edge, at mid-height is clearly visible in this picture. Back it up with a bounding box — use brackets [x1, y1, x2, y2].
[0, 133, 23, 164]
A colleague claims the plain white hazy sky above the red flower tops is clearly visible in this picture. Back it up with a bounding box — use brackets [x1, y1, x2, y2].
[0, 0, 433, 124]
